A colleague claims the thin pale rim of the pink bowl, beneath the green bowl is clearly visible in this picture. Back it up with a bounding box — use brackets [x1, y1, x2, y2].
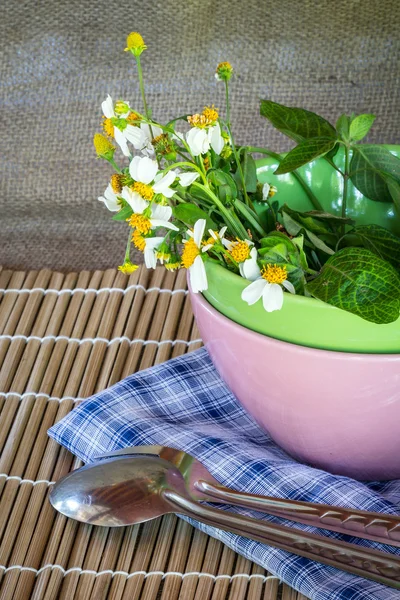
[187, 273, 400, 358]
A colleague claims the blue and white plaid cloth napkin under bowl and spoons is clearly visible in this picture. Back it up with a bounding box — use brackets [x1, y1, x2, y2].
[49, 348, 400, 600]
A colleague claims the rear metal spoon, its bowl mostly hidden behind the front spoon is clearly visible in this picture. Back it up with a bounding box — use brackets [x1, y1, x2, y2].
[95, 446, 400, 547]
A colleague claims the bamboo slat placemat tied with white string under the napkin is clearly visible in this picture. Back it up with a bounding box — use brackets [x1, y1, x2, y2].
[0, 268, 305, 600]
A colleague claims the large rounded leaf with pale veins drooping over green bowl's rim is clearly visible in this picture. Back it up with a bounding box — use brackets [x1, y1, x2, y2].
[307, 248, 400, 323]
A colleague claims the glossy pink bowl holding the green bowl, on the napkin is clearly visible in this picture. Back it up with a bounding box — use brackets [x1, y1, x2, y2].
[191, 293, 400, 480]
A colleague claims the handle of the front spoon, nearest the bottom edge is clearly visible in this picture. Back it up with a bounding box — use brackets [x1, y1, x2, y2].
[162, 490, 400, 589]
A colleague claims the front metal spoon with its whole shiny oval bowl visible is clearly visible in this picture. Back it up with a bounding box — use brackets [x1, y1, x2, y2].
[50, 455, 400, 589]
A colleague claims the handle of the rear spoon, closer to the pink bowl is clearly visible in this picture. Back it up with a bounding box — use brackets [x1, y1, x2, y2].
[192, 480, 400, 547]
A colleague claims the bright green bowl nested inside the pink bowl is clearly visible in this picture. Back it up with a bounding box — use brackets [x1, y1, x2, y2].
[203, 146, 400, 354]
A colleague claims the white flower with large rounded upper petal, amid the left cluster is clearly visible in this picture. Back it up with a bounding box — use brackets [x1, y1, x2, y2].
[129, 156, 177, 199]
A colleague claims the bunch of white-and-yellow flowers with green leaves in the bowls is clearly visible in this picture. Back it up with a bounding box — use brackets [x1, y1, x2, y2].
[94, 33, 400, 324]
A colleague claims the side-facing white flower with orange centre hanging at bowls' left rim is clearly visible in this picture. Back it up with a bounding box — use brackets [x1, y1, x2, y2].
[181, 219, 208, 294]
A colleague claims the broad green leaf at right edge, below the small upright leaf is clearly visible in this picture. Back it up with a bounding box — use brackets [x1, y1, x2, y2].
[350, 144, 400, 202]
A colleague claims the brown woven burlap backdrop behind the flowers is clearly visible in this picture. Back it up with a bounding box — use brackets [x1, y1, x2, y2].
[0, 0, 400, 269]
